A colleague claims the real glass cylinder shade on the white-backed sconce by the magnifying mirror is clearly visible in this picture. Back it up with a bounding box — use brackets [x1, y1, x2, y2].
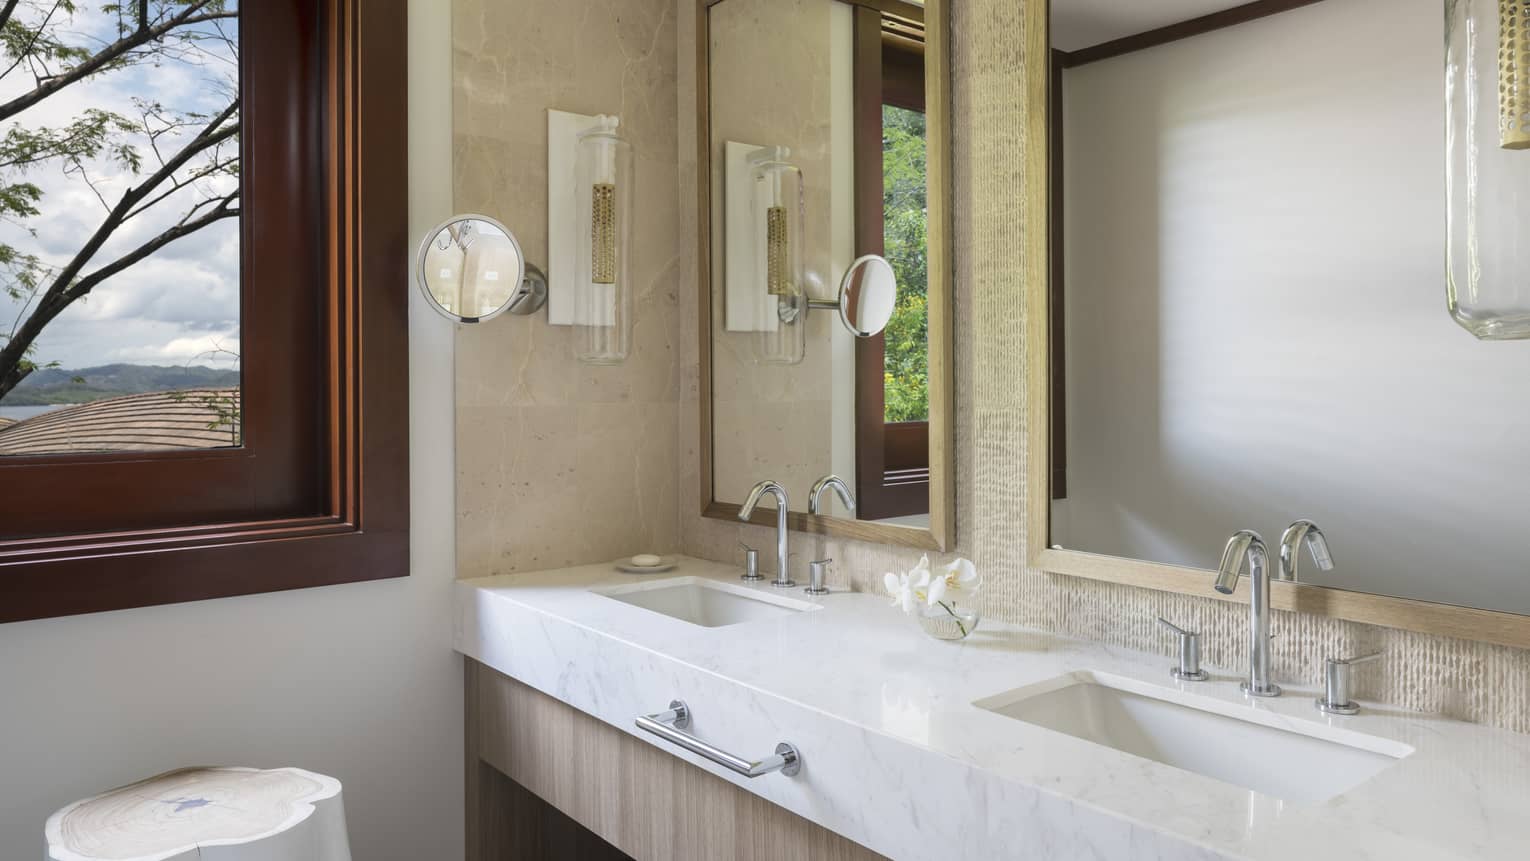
[574, 116, 633, 364]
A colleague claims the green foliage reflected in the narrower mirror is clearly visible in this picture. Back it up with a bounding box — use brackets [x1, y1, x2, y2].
[881, 106, 930, 422]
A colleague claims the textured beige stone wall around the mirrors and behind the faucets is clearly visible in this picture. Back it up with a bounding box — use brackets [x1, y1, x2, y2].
[675, 0, 1530, 731]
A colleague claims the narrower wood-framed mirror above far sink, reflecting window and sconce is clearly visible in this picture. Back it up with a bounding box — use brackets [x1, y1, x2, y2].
[698, 0, 955, 549]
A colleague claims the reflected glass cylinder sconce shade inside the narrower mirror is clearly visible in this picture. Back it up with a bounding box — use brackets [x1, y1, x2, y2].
[750, 147, 808, 364]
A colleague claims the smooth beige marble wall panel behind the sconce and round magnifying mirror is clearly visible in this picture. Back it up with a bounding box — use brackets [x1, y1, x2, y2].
[442, 0, 681, 577]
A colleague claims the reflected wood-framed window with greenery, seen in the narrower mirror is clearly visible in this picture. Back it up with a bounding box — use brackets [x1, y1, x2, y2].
[855, 8, 930, 520]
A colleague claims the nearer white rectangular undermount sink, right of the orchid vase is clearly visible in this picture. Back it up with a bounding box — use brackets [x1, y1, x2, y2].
[973, 671, 1414, 801]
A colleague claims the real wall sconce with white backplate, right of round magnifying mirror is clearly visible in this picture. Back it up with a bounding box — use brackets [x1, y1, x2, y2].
[548, 110, 635, 364]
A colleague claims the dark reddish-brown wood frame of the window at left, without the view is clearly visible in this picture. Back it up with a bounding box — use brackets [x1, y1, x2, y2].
[0, 0, 409, 622]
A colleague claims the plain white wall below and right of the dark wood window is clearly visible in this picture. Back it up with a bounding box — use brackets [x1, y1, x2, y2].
[0, 0, 462, 861]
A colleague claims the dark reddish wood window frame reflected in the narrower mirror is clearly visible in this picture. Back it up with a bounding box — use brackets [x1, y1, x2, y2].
[854, 6, 930, 520]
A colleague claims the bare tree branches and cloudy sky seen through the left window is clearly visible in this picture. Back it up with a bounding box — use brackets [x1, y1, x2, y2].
[0, 0, 240, 451]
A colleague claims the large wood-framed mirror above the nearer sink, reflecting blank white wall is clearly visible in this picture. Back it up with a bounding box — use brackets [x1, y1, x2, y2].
[1028, 0, 1530, 647]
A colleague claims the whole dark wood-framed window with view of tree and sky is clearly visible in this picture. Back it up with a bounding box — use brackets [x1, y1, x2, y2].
[0, 0, 409, 621]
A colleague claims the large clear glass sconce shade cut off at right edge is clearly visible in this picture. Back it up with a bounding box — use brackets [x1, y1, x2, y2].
[1446, 0, 1530, 341]
